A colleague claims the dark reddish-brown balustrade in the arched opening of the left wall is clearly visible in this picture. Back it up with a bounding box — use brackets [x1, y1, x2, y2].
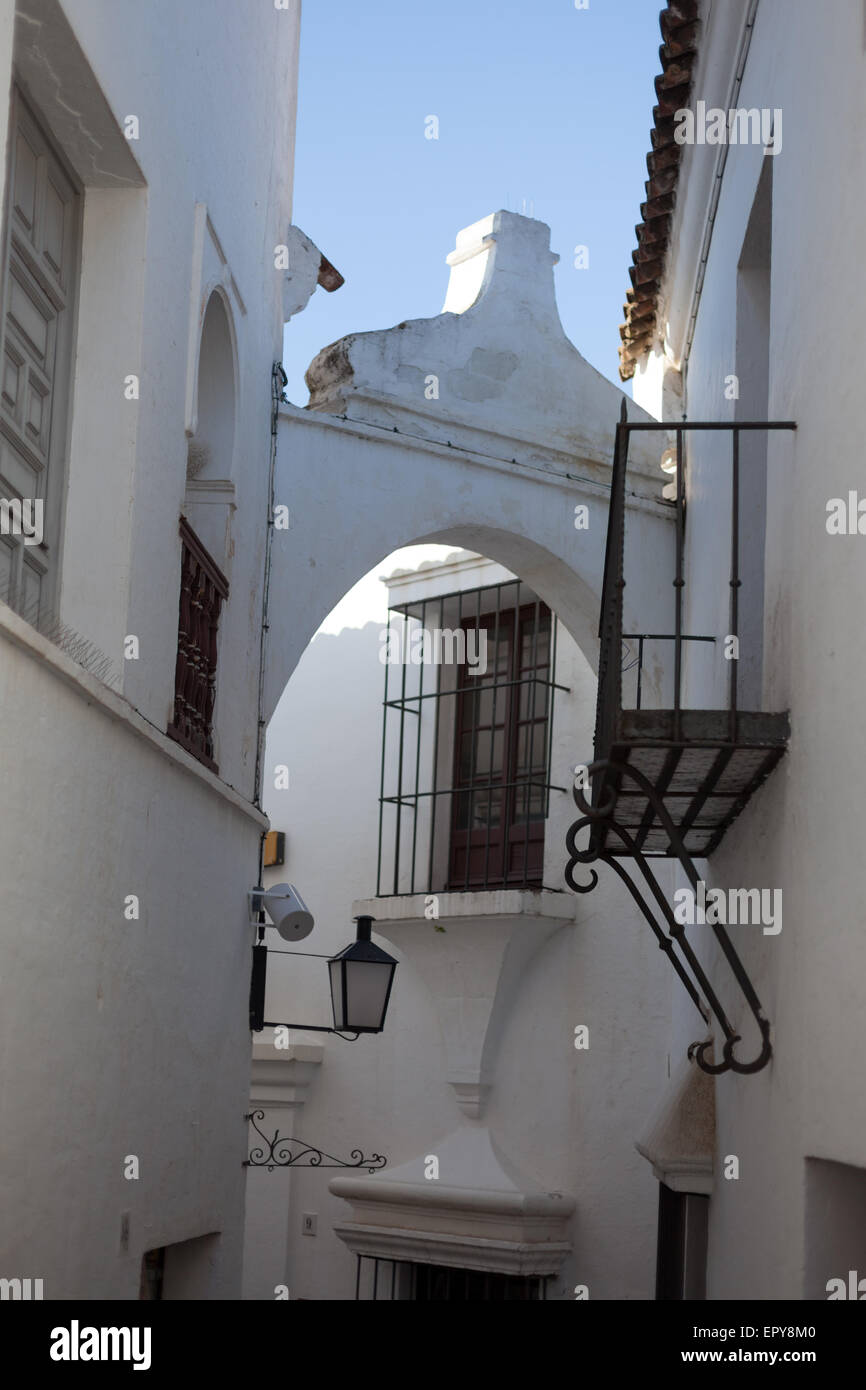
[167, 517, 228, 773]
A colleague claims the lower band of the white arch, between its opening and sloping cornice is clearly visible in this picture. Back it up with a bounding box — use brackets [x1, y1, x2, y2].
[264, 407, 670, 719]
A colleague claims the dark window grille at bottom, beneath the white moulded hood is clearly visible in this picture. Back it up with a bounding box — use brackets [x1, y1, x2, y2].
[354, 1255, 549, 1302]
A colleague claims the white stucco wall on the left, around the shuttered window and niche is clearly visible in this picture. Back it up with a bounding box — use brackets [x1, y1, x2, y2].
[0, 0, 300, 1298]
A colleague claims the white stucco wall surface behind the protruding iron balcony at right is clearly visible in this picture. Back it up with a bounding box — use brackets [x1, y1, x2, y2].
[635, 0, 866, 1298]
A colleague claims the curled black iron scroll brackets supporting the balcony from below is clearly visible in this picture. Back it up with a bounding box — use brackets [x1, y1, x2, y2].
[564, 759, 773, 1076]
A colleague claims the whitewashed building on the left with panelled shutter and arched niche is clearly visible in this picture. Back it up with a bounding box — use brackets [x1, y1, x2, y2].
[0, 0, 339, 1300]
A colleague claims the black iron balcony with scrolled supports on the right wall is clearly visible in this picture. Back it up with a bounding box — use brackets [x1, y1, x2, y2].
[566, 404, 796, 1073]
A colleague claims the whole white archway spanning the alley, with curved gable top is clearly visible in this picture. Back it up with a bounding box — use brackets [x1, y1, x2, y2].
[264, 211, 673, 719]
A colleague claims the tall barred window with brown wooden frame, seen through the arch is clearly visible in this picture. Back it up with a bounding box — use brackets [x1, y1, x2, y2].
[377, 580, 566, 897]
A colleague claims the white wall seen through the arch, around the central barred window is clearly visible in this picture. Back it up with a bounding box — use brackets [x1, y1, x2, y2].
[245, 553, 678, 1300]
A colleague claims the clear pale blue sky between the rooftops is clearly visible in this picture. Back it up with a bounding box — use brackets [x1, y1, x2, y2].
[285, 0, 662, 404]
